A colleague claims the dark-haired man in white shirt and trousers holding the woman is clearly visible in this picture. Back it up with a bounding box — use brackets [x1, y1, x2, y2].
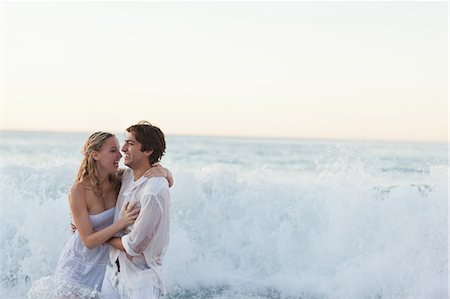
[102, 122, 170, 299]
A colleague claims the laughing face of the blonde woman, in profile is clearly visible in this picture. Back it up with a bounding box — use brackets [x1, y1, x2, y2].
[94, 136, 122, 173]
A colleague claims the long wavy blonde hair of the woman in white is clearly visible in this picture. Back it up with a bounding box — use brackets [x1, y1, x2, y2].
[76, 132, 120, 196]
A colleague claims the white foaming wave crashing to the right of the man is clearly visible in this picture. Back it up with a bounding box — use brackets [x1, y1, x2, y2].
[163, 167, 447, 298]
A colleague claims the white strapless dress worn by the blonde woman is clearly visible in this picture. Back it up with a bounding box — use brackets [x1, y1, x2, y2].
[28, 208, 114, 299]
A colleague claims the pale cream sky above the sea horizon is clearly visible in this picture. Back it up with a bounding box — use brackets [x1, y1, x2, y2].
[0, 1, 448, 142]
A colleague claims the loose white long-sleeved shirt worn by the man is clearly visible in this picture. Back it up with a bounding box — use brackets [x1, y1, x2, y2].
[109, 169, 170, 293]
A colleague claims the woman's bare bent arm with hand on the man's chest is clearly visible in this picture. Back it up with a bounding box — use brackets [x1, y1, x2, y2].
[69, 183, 139, 249]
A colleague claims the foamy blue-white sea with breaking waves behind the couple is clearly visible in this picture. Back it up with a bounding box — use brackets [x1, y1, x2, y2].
[0, 131, 449, 299]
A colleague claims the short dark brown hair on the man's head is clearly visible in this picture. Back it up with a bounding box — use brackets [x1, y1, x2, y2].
[127, 121, 166, 164]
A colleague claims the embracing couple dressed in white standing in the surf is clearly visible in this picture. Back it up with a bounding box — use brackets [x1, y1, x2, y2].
[28, 122, 173, 299]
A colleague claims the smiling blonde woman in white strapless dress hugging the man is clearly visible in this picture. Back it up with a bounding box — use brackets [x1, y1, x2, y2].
[28, 132, 173, 298]
